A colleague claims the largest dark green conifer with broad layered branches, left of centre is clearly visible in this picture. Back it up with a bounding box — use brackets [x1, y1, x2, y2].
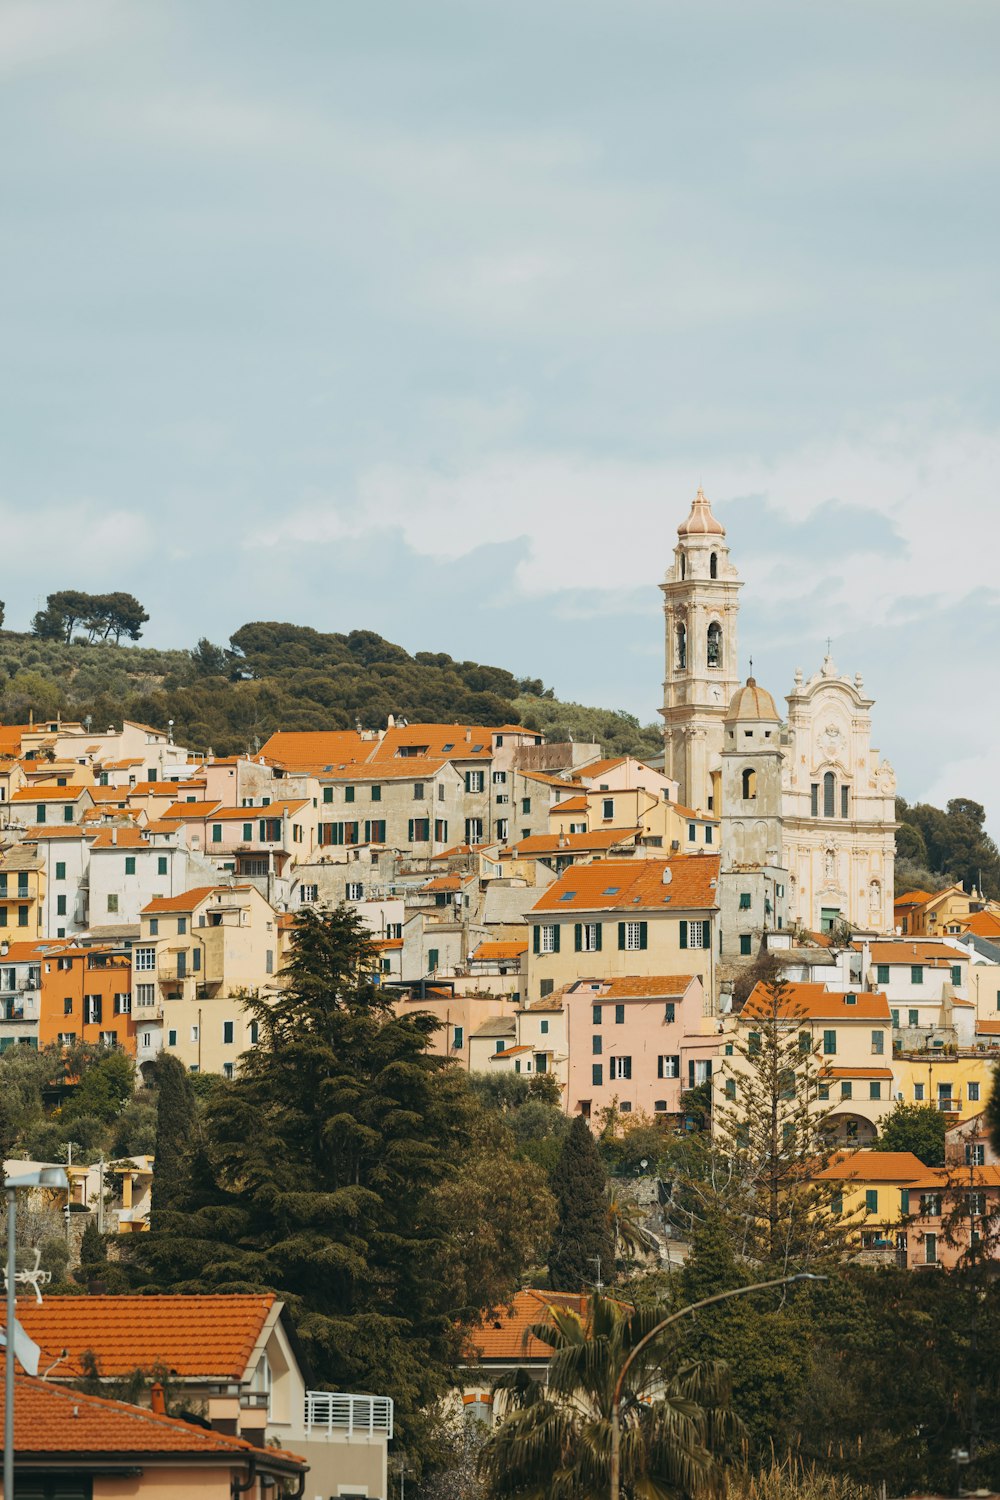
[130, 908, 471, 1434]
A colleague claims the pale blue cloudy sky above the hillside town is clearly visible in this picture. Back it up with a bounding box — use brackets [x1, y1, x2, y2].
[0, 0, 1000, 824]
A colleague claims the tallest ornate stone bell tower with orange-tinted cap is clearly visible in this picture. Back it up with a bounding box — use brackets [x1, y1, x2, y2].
[660, 489, 742, 813]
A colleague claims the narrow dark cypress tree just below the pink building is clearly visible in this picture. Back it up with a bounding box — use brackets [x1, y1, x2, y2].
[549, 1115, 615, 1292]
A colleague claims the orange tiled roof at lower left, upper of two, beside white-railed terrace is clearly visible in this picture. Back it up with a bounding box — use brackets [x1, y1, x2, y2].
[0, 1292, 274, 1380]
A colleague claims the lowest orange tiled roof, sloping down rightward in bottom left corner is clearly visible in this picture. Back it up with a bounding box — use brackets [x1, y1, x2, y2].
[0, 1374, 306, 1473]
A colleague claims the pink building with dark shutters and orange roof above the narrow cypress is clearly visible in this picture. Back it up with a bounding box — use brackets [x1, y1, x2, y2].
[564, 974, 721, 1119]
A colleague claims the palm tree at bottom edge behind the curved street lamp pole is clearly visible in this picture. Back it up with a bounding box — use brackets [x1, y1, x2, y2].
[480, 1295, 738, 1500]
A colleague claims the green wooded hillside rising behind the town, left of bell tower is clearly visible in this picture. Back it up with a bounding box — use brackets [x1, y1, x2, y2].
[0, 623, 663, 755]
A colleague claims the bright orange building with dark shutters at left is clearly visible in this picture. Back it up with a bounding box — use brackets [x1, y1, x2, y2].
[37, 945, 135, 1058]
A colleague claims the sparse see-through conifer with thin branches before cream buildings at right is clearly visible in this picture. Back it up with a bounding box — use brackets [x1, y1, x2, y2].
[714, 977, 856, 1268]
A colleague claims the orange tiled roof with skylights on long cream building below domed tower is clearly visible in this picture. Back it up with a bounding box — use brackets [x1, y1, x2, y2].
[531, 854, 719, 912]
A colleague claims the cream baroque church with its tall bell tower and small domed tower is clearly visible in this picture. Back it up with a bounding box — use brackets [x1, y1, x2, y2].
[661, 489, 897, 959]
